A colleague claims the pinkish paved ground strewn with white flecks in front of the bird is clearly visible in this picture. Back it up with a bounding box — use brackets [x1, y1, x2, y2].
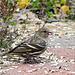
[1, 48, 75, 75]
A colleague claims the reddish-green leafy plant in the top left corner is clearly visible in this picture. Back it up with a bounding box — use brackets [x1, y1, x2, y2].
[0, 0, 16, 23]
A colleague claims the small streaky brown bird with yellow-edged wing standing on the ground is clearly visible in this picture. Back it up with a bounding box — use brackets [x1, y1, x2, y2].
[2, 28, 52, 62]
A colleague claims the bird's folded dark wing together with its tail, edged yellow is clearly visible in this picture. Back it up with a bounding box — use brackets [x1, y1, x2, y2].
[2, 42, 45, 56]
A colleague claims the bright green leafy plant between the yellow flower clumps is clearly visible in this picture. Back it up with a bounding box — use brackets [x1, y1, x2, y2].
[30, 0, 60, 21]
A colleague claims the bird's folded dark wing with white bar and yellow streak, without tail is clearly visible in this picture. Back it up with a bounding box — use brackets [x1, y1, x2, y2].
[11, 43, 45, 53]
